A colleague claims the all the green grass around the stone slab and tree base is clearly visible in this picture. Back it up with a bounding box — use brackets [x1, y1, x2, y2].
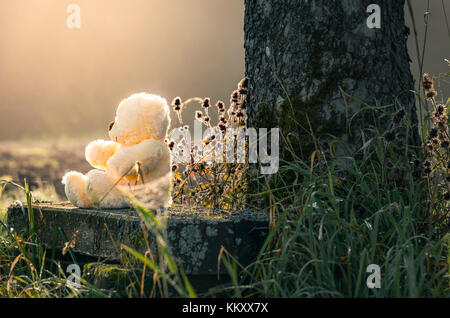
[0, 110, 450, 298]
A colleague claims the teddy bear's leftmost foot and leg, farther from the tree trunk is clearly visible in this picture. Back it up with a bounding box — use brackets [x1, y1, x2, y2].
[62, 171, 93, 208]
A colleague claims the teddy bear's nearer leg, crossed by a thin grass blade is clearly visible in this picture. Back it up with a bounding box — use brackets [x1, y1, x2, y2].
[86, 169, 130, 209]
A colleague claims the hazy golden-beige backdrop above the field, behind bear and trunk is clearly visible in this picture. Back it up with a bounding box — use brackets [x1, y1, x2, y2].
[0, 0, 450, 140]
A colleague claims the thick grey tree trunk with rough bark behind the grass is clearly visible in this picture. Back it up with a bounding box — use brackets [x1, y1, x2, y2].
[244, 0, 418, 157]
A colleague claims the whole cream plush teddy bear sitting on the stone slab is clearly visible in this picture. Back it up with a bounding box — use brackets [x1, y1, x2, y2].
[62, 93, 171, 209]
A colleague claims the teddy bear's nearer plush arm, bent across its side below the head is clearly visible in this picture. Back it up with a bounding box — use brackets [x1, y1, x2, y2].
[108, 139, 167, 177]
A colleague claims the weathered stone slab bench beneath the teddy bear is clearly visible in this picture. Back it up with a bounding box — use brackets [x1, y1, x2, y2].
[8, 203, 269, 276]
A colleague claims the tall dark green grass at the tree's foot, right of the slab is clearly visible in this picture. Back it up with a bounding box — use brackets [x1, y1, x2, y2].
[225, 138, 450, 297]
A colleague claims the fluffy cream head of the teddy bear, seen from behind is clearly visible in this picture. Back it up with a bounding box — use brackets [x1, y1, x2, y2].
[109, 93, 170, 146]
